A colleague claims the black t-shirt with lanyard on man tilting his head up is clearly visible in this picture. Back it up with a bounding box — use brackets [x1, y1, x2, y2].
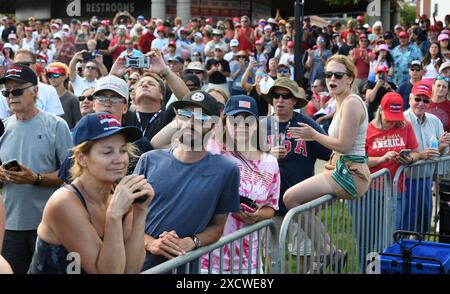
[124, 108, 175, 141]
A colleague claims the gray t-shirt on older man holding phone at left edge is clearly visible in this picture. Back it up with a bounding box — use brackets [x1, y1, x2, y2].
[0, 111, 72, 231]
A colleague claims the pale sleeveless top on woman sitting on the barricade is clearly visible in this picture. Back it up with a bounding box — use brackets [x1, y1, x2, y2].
[328, 94, 369, 156]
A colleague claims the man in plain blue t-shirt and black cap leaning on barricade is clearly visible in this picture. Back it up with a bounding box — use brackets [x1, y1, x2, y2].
[134, 91, 239, 273]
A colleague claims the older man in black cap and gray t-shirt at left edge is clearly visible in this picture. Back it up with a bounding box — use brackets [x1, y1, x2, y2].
[0, 65, 72, 274]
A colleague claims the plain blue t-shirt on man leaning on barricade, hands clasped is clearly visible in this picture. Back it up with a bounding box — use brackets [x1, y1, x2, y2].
[134, 149, 239, 269]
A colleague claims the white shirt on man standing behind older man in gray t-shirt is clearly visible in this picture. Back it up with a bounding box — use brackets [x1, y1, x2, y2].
[0, 82, 64, 119]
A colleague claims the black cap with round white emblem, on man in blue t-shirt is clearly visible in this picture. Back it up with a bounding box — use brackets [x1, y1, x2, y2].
[172, 91, 220, 116]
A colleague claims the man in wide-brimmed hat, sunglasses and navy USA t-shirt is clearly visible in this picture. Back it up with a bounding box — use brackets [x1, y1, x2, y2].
[261, 78, 331, 264]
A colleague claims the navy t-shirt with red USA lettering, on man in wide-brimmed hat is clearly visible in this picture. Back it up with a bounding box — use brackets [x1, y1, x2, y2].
[260, 112, 331, 215]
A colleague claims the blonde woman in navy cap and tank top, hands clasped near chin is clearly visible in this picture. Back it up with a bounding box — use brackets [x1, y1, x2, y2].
[29, 113, 154, 274]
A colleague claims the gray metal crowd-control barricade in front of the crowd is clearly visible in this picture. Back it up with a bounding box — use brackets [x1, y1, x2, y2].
[143, 156, 450, 274]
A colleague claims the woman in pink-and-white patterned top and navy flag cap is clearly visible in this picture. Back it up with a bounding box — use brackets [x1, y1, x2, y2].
[202, 95, 280, 273]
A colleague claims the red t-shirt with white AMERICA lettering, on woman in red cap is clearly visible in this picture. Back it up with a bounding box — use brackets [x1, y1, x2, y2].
[366, 122, 419, 189]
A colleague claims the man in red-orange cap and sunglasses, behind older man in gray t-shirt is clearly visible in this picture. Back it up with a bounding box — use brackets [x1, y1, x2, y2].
[47, 62, 81, 129]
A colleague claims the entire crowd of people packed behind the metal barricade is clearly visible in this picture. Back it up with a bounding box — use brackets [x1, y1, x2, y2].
[0, 12, 450, 273]
